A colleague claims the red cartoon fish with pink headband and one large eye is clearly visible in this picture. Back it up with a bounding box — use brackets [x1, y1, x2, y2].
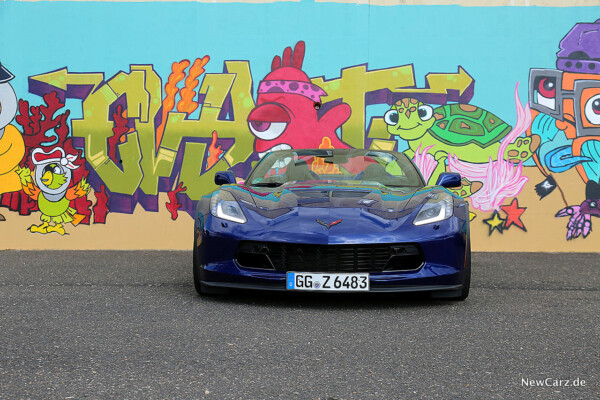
[248, 41, 352, 158]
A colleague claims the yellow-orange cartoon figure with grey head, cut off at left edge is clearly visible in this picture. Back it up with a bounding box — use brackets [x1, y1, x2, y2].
[0, 64, 25, 221]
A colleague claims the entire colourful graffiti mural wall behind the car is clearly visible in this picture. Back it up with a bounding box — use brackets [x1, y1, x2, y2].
[0, 0, 600, 251]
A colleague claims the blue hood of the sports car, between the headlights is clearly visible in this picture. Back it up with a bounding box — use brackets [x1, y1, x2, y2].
[216, 183, 440, 243]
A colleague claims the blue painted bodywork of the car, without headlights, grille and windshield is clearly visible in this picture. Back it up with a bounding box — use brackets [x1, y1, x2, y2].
[194, 150, 470, 298]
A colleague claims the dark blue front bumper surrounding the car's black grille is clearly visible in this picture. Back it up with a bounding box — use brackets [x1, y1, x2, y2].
[195, 209, 468, 292]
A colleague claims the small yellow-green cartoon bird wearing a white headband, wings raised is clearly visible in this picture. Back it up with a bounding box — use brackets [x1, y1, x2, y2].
[19, 147, 90, 235]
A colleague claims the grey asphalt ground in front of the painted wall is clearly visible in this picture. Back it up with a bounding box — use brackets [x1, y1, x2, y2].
[0, 251, 600, 400]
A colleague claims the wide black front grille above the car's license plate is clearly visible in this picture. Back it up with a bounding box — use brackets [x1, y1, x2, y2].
[236, 241, 425, 272]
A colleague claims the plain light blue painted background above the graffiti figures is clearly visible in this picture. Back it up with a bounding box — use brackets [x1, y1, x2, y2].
[0, 0, 600, 122]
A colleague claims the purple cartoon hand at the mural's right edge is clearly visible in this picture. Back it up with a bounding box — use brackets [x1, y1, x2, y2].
[556, 181, 600, 240]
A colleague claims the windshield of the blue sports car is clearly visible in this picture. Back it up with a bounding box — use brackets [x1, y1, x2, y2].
[246, 149, 424, 187]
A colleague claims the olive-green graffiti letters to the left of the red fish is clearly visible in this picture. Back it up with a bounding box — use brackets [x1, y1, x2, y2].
[66, 61, 254, 200]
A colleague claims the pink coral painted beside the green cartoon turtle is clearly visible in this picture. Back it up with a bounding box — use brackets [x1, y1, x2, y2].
[448, 83, 531, 212]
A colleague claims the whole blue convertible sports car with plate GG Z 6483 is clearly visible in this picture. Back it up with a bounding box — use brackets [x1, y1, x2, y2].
[193, 149, 471, 300]
